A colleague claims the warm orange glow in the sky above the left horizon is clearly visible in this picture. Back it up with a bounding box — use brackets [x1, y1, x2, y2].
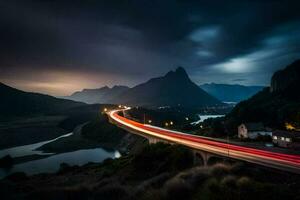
[0, 71, 131, 96]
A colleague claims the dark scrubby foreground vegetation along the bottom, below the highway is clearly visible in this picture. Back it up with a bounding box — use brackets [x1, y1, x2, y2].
[0, 143, 300, 200]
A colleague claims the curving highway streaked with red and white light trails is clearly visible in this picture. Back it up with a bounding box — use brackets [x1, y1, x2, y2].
[107, 109, 300, 174]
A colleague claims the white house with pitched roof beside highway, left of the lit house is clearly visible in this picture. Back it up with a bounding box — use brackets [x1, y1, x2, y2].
[238, 123, 272, 139]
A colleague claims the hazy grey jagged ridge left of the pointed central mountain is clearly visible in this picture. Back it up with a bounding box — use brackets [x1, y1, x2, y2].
[64, 85, 129, 104]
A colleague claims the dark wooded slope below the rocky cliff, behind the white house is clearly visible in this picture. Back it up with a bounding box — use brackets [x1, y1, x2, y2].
[226, 88, 300, 132]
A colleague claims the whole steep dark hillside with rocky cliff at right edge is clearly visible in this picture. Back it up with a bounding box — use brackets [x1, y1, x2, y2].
[227, 60, 300, 128]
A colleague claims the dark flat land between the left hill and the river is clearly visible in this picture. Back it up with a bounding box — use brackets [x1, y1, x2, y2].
[0, 104, 115, 150]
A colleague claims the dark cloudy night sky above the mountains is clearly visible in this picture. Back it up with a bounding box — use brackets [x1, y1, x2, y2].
[0, 0, 300, 95]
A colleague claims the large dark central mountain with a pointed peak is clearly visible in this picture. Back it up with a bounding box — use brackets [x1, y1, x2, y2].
[113, 67, 222, 107]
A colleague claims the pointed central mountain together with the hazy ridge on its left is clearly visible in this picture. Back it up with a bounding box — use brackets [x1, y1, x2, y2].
[67, 67, 222, 107]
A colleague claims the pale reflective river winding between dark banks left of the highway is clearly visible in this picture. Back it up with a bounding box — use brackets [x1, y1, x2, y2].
[0, 133, 121, 178]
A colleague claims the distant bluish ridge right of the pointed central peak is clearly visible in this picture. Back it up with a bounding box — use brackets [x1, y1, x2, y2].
[200, 83, 264, 102]
